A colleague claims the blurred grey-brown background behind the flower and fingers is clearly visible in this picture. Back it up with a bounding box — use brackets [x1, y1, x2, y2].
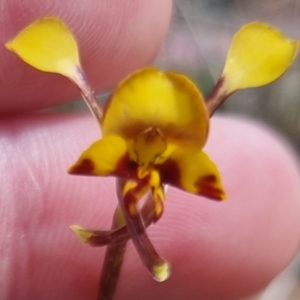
[55, 0, 300, 300]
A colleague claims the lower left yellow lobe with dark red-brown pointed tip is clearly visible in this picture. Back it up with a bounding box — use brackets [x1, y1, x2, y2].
[68, 136, 130, 176]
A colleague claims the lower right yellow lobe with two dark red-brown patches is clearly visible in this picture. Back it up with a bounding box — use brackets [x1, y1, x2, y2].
[159, 147, 225, 200]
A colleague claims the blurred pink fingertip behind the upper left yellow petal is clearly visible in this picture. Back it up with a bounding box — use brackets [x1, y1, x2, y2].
[0, 0, 172, 114]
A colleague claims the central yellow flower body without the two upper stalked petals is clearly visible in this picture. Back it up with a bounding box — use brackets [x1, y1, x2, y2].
[69, 68, 225, 211]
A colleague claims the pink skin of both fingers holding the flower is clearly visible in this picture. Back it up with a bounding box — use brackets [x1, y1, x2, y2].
[0, 0, 300, 300]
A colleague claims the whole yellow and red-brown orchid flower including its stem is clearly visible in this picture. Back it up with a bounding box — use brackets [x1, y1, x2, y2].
[6, 17, 298, 299]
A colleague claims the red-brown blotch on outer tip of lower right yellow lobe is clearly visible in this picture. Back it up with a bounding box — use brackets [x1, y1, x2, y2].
[195, 175, 225, 200]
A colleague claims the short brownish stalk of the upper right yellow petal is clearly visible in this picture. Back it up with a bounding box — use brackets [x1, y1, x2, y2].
[206, 77, 232, 117]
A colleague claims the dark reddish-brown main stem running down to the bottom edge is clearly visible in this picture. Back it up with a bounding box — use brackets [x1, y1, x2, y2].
[97, 207, 127, 300]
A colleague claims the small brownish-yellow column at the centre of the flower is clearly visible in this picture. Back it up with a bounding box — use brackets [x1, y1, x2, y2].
[132, 127, 167, 168]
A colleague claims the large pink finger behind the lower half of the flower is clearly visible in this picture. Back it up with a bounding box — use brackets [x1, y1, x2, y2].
[0, 115, 300, 300]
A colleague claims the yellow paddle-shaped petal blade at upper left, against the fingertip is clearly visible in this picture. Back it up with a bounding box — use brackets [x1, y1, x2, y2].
[5, 17, 79, 78]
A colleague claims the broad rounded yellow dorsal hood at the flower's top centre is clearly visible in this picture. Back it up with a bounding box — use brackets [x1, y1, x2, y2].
[102, 68, 208, 147]
